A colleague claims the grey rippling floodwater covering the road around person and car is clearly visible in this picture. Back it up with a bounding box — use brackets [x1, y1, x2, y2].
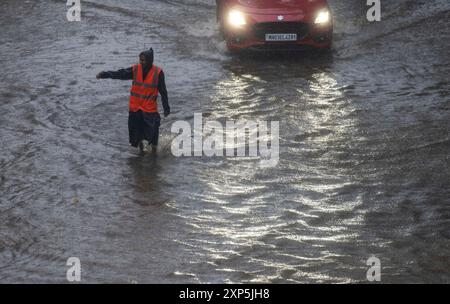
[0, 0, 450, 283]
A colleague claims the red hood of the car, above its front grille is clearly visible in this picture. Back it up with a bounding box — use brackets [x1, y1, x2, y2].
[236, 0, 326, 14]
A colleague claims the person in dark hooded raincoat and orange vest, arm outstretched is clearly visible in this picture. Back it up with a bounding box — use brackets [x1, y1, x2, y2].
[97, 48, 170, 154]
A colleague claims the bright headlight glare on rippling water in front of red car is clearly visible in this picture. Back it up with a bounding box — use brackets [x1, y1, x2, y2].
[184, 56, 370, 282]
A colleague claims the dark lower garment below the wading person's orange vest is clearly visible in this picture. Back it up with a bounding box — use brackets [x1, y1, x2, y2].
[128, 111, 161, 147]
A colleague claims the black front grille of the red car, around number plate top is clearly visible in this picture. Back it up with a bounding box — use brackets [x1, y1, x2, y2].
[253, 22, 309, 40]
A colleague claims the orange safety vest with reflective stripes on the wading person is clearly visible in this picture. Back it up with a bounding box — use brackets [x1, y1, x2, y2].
[130, 64, 161, 113]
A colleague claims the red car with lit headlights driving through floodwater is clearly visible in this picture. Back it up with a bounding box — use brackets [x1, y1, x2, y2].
[216, 0, 333, 51]
